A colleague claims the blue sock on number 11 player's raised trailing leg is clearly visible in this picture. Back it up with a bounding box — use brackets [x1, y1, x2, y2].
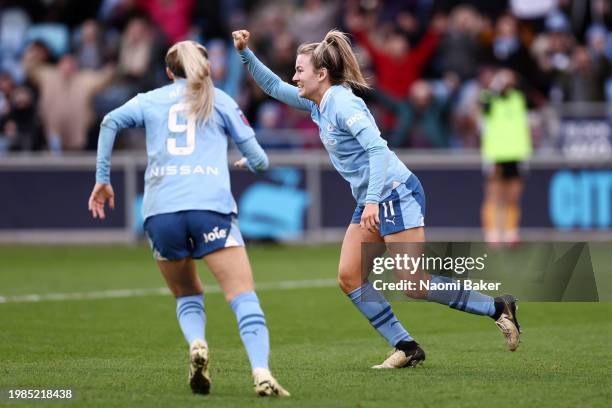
[427, 275, 495, 316]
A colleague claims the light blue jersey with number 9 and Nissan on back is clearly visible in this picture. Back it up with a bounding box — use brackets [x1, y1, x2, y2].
[96, 80, 255, 219]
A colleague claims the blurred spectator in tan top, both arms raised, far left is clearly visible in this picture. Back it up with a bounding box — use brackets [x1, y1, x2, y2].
[22, 44, 114, 153]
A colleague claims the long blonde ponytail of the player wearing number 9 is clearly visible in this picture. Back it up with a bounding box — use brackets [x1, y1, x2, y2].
[166, 41, 214, 121]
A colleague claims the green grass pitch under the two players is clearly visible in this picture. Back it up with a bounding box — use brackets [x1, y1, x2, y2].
[0, 246, 612, 407]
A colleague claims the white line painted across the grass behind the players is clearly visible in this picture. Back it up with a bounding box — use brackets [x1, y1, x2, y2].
[0, 279, 338, 304]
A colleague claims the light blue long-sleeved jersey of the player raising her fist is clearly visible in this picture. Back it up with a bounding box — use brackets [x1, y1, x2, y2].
[240, 48, 412, 205]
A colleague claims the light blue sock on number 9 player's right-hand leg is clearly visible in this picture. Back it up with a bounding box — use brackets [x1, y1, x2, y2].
[230, 292, 270, 370]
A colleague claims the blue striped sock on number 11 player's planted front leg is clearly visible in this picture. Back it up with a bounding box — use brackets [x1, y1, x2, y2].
[348, 282, 414, 347]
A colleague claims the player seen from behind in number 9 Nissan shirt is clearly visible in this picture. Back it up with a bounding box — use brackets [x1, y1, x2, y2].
[89, 41, 289, 396]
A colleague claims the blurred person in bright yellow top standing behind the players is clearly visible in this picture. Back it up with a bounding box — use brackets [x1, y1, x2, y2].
[480, 69, 532, 245]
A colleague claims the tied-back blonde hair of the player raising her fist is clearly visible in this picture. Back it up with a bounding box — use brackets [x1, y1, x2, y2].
[297, 30, 370, 90]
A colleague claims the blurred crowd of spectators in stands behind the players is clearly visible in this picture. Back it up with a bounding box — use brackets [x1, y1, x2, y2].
[0, 0, 612, 153]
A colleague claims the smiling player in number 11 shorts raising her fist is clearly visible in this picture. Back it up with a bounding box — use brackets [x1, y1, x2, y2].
[232, 30, 519, 368]
